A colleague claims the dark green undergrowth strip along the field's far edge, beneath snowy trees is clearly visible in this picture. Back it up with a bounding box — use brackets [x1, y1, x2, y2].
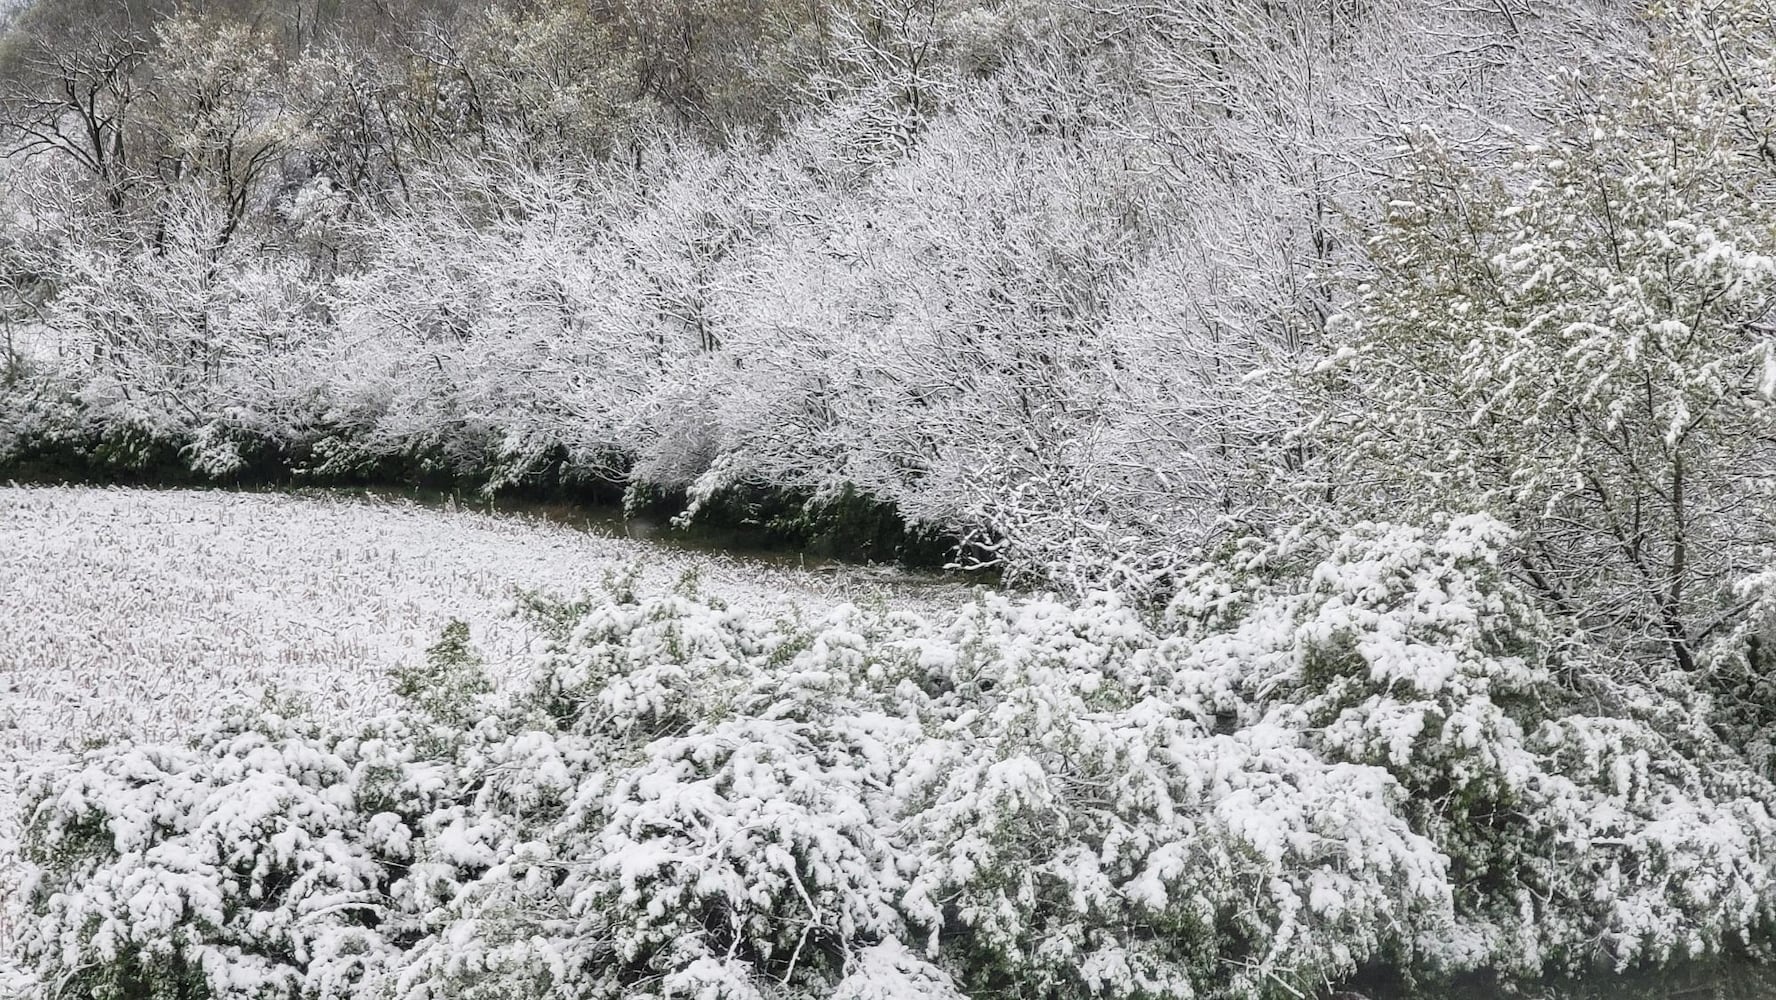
[0, 382, 971, 567]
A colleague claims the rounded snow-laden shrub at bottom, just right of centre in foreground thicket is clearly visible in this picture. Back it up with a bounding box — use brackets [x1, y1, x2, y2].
[906, 618, 1449, 996]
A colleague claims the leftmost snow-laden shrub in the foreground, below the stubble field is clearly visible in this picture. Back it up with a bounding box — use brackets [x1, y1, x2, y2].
[20, 712, 451, 1000]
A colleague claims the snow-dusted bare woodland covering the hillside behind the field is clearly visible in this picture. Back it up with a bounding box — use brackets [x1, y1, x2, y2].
[0, 0, 1655, 584]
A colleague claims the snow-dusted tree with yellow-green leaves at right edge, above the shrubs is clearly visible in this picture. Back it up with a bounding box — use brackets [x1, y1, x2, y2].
[1321, 50, 1776, 670]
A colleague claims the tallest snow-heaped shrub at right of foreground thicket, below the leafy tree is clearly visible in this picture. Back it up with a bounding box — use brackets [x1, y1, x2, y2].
[1170, 517, 1776, 975]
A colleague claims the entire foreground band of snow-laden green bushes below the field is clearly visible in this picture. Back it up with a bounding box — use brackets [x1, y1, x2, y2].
[21, 519, 1776, 1000]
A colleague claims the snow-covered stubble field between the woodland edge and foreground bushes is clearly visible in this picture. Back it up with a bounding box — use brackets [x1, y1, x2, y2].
[0, 487, 966, 950]
